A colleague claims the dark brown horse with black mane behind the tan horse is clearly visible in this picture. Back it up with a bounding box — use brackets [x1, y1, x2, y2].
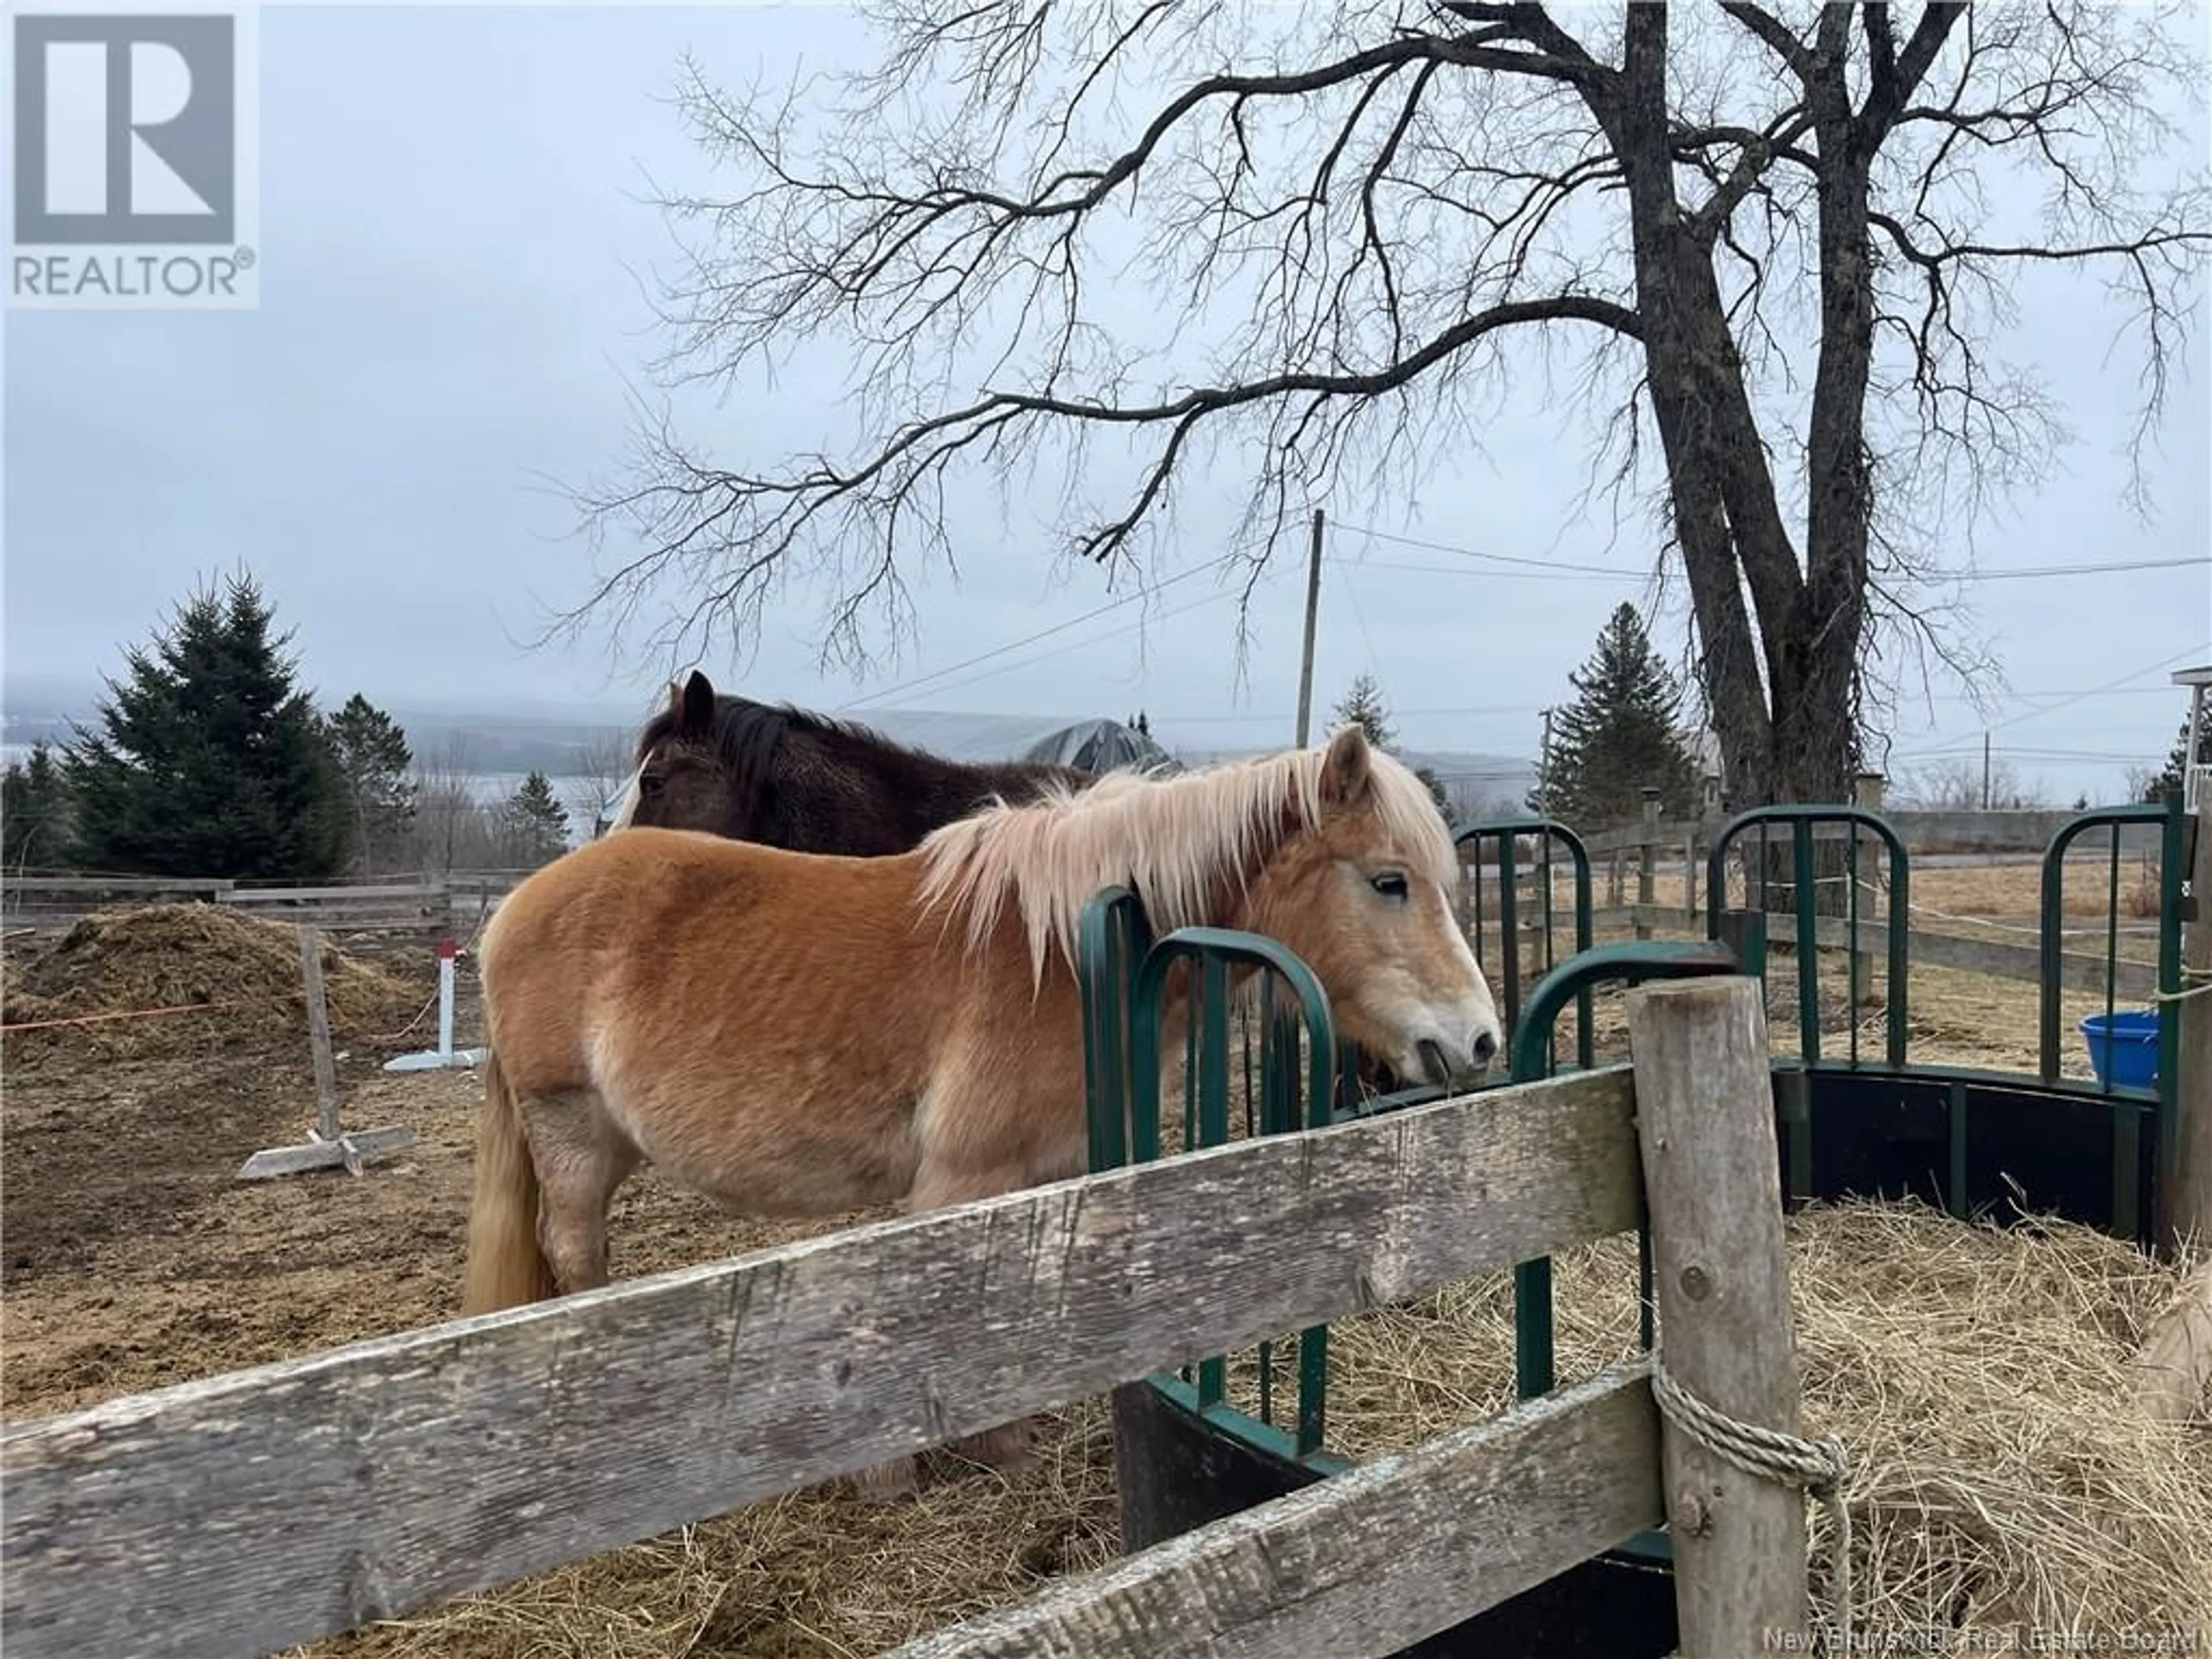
[613, 671, 1093, 858]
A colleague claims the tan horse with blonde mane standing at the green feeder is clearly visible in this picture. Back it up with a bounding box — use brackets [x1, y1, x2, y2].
[463, 726, 1502, 1493]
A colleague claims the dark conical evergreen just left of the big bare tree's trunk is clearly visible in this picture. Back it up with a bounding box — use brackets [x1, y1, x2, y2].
[1528, 604, 1696, 830]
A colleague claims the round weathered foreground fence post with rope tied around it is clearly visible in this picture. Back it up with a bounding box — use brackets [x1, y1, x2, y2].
[1628, 975, 1825, 1659]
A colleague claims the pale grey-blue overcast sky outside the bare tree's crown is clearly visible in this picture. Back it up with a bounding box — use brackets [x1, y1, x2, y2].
[5, 7, 2212, 794]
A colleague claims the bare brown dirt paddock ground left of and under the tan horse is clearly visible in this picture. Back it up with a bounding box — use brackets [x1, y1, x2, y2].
[0, 1009, 871, 1418]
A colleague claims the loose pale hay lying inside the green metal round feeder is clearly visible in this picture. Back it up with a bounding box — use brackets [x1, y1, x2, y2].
[1232, 1203, 2212, 1652]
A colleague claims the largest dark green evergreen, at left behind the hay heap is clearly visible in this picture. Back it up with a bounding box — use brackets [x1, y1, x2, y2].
[62, 575, 345, 880]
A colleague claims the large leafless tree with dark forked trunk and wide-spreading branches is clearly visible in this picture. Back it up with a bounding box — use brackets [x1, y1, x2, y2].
[566, 0, 2212, 827]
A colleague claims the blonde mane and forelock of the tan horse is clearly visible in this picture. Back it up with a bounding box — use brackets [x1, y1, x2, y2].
[920, 743, 1458, 980]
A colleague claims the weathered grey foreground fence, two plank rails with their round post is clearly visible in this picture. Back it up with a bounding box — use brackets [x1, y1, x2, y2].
[0, 978, 1805, 1659]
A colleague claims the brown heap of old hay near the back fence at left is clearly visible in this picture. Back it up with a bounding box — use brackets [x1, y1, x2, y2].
[0, 905, 425, 1062]
